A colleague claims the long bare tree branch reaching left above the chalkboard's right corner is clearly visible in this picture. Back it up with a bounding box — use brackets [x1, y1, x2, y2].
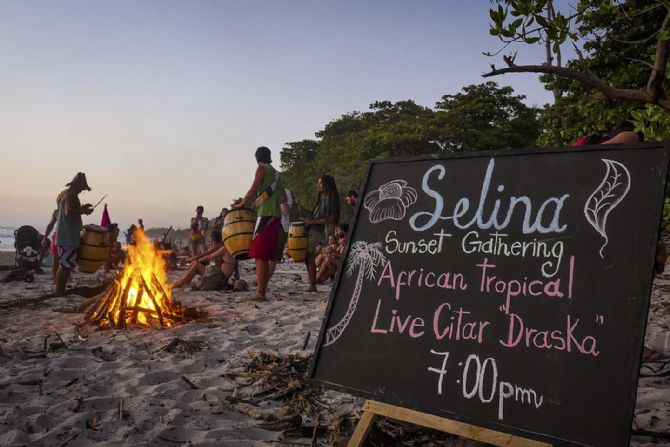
[482, 55, 670, 110]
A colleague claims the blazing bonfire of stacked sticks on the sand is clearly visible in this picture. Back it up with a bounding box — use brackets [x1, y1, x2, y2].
[87, 228, 177, 327]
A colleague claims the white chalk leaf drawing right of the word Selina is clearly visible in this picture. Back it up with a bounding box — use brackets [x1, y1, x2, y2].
[584, 158, 630, 259]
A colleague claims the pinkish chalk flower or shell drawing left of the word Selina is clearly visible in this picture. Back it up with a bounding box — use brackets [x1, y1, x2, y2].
[363, 180, 417, 223]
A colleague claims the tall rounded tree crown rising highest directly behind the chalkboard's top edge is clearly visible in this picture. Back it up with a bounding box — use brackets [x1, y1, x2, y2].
[435, 82, 540, 152]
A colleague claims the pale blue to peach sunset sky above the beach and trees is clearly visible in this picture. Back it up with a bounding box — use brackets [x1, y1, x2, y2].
[0, 0, 551, 234]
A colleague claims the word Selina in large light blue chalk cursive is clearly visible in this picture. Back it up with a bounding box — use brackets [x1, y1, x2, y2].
[409, 158, 570, 234]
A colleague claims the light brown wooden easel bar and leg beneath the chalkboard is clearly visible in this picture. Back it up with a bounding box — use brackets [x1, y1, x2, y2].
[347, 400, 552, 447]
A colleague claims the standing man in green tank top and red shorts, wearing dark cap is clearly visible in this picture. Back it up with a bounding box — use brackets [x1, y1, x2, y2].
[233, 146, 286, 301]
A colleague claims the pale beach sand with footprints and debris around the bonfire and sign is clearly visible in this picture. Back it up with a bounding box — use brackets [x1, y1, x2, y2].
[0, 253, 670, 447]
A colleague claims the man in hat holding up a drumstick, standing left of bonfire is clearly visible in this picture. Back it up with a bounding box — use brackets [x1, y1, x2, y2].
[56, 172, 93, 293]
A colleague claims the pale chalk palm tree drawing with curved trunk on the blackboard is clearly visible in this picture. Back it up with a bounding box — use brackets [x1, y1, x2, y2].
[323, 241, 386, 346]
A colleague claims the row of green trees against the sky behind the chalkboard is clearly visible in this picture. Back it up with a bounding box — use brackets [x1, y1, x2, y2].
[281, 82, 539, 210]
